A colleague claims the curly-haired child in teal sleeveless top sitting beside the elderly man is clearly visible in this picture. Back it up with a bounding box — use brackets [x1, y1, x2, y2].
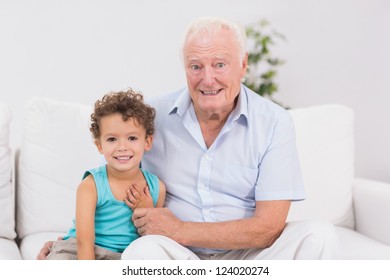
[47, 89, 165, 259]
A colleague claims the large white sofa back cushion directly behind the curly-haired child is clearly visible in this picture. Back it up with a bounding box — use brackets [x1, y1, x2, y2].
[17, 97, 102, 238]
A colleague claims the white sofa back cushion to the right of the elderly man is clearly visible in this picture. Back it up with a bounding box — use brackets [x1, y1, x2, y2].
[288, 104, 354, 228]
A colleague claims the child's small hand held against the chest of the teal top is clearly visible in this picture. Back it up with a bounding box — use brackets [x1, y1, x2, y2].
[124, 185, 153, 211]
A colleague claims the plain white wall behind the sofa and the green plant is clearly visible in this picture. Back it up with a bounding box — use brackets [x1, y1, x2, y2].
[0, 0, 390, 182]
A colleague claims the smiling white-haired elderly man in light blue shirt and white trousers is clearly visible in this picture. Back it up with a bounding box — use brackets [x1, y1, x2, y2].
[122, 18, 338, 259]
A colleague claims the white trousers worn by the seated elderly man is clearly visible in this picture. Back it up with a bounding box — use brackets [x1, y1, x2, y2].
[122, 221, 341, 260]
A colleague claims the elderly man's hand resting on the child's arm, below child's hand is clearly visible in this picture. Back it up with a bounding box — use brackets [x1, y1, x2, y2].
[132, 208, 183, 241]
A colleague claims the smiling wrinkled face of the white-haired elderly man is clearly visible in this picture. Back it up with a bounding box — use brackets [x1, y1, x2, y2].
[183, 29, 247, 114]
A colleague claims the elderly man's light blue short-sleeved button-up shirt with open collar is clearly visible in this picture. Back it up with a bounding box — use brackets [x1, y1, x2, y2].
[142, 86, 304, 253]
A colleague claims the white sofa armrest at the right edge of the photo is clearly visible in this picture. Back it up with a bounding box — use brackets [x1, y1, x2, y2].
[353, 178, 390, 245]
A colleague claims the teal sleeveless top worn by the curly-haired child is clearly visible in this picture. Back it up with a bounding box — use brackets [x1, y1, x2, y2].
[64, 165, 159, 253]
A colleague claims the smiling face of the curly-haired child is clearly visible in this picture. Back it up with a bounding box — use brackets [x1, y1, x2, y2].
[96, 114, 153, 171]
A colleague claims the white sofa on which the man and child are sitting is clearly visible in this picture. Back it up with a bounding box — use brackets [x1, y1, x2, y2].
[0, 97, 390, 259]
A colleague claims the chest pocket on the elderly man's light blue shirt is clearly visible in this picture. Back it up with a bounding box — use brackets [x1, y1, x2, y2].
[223, 164, 259, 206]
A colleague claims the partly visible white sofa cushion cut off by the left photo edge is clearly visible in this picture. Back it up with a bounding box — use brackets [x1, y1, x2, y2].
[0, 103, 16, 239]
